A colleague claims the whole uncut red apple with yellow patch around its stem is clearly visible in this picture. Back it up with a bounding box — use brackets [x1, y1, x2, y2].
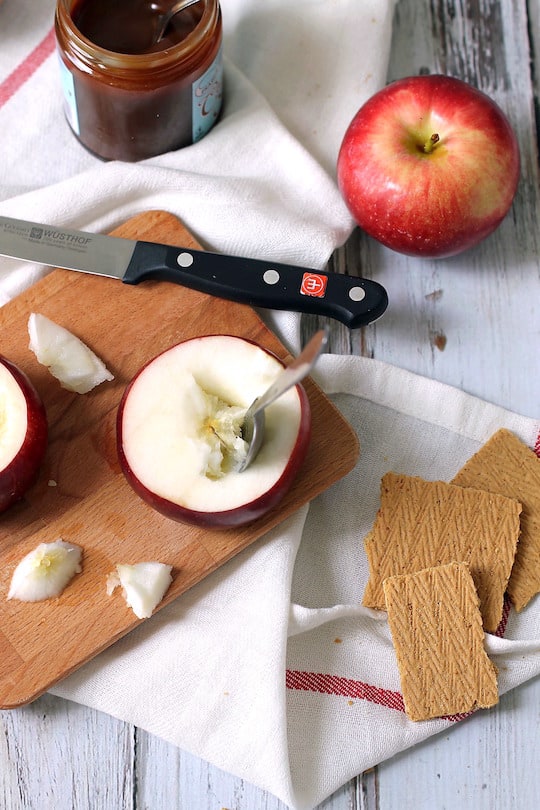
[337, 75, 520, 258]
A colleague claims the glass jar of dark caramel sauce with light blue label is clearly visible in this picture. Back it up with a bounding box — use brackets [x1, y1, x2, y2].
[55, 0, 223, 161]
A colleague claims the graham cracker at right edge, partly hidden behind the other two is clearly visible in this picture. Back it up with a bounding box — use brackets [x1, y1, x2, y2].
[452, 429, 540, 611]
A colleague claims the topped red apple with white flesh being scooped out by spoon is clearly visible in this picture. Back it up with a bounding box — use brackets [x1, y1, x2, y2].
[117, 335, 311, 528]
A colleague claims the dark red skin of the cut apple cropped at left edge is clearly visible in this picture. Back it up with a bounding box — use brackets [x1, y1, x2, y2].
[0, 355, 48, 512]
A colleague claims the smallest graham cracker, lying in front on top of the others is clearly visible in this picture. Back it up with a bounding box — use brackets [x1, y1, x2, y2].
[383, 562, 499, 720]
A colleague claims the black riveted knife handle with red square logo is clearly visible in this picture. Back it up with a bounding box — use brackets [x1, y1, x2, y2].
[122, 241, 388, 329]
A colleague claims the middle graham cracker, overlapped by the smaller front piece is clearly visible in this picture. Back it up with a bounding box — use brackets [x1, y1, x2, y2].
[363, 472, 521, 632]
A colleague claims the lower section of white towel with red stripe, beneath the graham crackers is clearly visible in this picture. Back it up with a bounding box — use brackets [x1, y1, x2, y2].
[47, 355, 540, 810]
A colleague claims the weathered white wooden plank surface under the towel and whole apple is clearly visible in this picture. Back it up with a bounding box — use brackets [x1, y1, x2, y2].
[0, 0, 540, 810]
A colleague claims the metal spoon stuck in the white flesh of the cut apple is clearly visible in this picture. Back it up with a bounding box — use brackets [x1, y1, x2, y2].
[238, 329, 328, 472]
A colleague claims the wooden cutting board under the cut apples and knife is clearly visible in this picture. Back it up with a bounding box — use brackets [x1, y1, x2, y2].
[0, 211, 359, 708]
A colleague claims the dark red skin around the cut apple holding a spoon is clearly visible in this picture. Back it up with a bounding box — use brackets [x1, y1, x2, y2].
[116, 335, 311, 529]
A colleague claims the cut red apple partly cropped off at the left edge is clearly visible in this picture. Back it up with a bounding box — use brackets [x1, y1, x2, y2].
[0, 356, 48, 512]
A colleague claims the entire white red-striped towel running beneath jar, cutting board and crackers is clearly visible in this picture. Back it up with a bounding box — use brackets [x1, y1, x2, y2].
[4, 0, 540, 808]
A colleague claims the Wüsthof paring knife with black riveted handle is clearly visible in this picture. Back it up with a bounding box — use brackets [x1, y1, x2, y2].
[0, 217, 388, 329]
